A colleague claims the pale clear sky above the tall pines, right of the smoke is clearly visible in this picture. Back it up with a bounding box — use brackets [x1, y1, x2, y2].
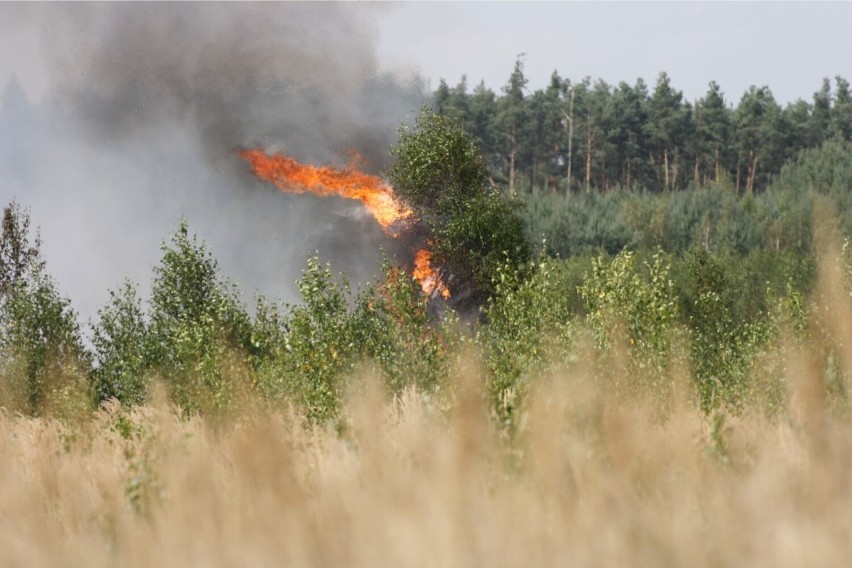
[377, 2, 852, 105]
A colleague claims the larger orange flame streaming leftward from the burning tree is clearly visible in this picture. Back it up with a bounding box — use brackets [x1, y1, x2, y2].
[240, 149, 412, 237]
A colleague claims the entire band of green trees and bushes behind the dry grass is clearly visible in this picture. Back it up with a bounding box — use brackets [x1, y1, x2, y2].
[5, 65, 852, 430]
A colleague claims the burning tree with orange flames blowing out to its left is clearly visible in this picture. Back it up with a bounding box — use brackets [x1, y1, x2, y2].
[240, 108, 529, 310]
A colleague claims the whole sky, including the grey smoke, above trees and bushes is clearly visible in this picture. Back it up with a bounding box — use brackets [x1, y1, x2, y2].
[0, 2, 852, 328]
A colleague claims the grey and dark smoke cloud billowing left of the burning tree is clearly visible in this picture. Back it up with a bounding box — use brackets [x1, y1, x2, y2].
[0, 3, 424, 324]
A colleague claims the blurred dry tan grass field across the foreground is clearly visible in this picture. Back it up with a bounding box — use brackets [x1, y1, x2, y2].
[0, 350, 852, 567]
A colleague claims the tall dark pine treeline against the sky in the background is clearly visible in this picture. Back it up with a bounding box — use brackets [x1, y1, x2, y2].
[433, 59, 852, 195]
